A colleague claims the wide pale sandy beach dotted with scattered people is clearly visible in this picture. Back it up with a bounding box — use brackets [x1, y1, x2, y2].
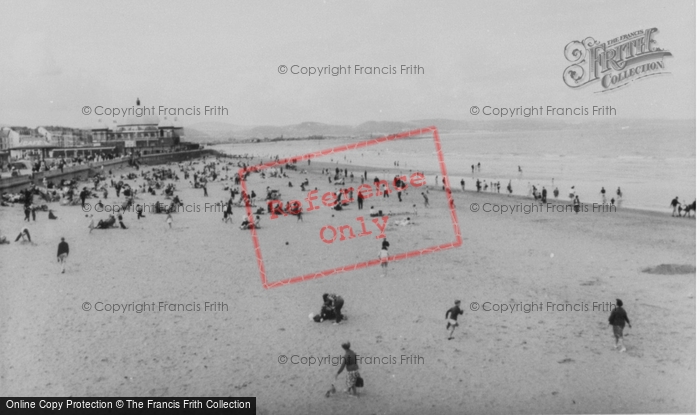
[0, 157, 696, 414]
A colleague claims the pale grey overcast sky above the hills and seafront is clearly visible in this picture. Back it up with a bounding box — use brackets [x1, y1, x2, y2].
[0, 0, 696, 127]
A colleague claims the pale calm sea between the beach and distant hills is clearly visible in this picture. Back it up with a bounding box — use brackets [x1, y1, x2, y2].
[214, 121, 696, 213]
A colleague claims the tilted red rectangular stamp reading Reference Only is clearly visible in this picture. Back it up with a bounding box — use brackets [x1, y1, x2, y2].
[239, 127, 462, 289]
